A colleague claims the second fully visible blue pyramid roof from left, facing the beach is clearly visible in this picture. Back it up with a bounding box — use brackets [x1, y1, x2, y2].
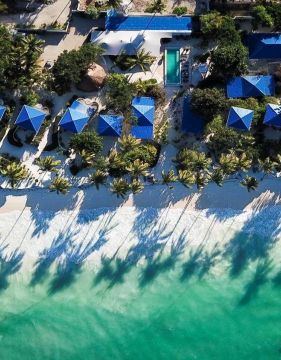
[59, 100, 94, 134]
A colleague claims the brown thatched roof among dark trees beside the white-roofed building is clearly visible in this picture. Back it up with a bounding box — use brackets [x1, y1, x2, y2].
[77, 63, 106, 91]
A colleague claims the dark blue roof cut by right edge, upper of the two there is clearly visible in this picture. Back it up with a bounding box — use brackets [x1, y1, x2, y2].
[247, 33, 281, 59]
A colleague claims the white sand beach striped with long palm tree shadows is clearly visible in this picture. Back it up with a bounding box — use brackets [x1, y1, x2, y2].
[0, 179, 281, 276]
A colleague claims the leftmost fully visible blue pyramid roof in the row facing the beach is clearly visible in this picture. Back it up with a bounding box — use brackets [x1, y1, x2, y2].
[16, 105, 46, 133]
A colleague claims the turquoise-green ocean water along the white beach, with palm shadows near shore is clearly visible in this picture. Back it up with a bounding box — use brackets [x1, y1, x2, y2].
[0, 236, 281, 360]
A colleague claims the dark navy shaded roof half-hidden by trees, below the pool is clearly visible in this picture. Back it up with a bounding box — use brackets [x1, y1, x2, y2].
[181, 97, 204, 134]
